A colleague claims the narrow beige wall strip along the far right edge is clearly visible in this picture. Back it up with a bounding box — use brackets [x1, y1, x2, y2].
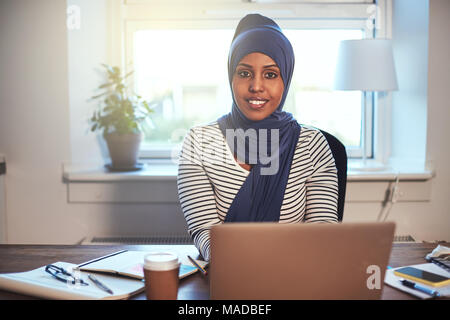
[417, 0, 450, 240]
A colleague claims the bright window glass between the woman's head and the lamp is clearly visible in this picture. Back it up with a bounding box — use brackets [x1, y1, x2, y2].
[284, 30, 363, 147]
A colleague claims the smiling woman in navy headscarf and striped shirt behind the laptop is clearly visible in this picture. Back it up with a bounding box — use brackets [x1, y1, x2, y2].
[178, 14, 338, 260]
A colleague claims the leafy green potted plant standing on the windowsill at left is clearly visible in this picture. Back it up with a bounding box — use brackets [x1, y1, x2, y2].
[90, 64, 153, 171]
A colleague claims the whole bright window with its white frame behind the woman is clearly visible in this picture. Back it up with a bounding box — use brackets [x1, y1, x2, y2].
[118, 0, 388, 158]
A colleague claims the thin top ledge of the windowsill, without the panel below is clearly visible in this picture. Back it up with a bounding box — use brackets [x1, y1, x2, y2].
[63, 159, 433, 182]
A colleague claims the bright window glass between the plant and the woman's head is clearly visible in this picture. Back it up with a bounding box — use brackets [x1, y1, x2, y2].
[134, 30, 233, 146]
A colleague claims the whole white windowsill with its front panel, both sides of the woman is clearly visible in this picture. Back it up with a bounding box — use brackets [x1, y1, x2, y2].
[63, 160, 433, 206]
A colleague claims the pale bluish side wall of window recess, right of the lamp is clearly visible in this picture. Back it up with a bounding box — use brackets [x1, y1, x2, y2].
[391, 0, 429, 163]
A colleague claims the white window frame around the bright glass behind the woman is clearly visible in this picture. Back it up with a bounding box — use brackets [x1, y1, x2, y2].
[112, 0, 392, 162]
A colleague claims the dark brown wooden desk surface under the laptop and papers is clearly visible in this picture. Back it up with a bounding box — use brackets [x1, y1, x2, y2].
[0, 243, 449, 300]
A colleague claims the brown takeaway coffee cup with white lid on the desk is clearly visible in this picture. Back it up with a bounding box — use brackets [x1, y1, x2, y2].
[144, 252, 180, 300]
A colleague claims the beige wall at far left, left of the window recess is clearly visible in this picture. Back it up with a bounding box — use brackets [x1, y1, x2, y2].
[0, 1, 74, 241]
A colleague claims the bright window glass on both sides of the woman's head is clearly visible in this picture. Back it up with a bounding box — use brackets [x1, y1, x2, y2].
[134, 29, 363, 148]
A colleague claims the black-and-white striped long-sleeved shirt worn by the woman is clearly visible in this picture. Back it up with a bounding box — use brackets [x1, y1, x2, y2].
[177, 122, 338, 260]
